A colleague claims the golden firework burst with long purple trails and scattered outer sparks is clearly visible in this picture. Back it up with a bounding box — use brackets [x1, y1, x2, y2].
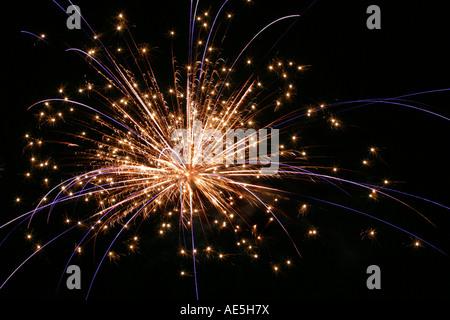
[0, 1, 448, 298]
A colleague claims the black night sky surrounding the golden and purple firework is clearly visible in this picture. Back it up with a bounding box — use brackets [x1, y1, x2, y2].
[0, 0, 450, 300]
